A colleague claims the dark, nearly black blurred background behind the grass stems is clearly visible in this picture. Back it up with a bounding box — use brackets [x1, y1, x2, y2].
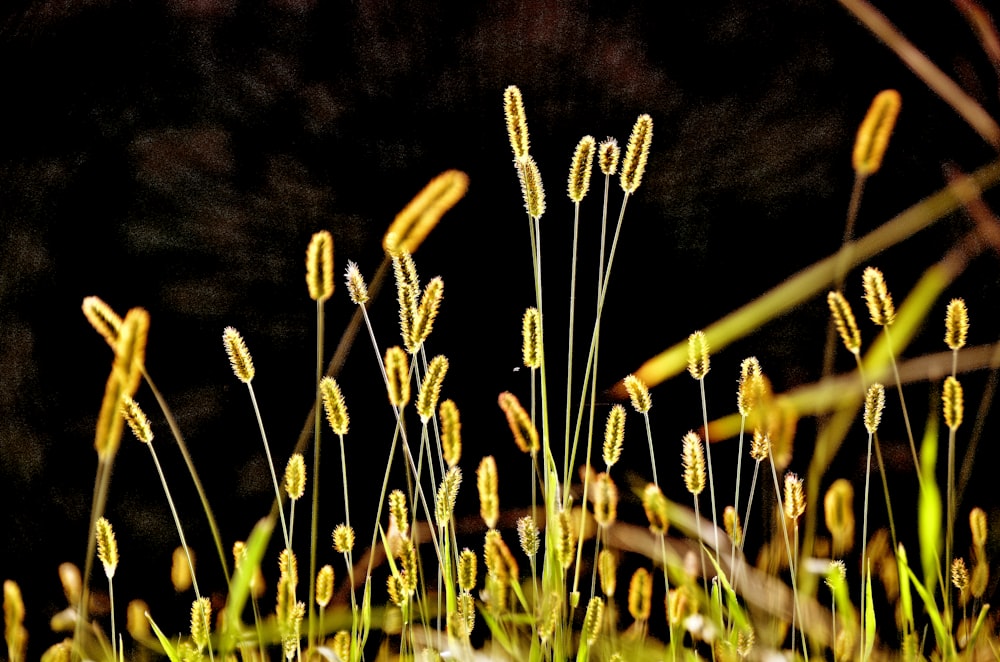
[0, 0, 1000, 657]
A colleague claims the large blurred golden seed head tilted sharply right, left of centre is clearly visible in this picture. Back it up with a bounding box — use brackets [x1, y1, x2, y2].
[382, 170, 469, 255]
